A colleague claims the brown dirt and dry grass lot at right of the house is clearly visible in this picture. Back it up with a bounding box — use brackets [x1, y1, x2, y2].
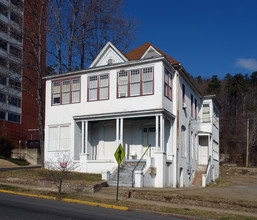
[118, 166, 257, 213]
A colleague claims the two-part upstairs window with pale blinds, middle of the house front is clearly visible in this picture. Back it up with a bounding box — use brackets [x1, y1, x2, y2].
[88, 74, 109, 101]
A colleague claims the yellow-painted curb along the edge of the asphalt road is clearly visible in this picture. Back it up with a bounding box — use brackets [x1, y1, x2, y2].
[0, 189, 129, 211]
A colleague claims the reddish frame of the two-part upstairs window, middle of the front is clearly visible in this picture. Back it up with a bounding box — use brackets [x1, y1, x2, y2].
[87, 73, 110, 102]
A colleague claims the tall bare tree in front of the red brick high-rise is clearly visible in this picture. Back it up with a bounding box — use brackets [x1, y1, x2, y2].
[22, 0, 47, 163]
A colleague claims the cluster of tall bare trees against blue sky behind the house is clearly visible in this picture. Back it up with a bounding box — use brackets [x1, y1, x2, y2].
[47, 0, 137, 73]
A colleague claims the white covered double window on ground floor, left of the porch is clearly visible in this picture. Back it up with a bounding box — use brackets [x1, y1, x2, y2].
[48, 125, 70, 151]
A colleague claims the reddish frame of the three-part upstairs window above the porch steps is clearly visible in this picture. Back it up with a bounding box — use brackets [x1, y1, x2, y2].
[116, 66, 154, 98]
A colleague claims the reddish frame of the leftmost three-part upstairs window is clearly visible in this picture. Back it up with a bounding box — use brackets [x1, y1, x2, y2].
[51, 76, 81, 106]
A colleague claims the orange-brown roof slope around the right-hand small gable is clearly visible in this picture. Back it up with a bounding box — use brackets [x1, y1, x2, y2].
[125, 42, 179, 64]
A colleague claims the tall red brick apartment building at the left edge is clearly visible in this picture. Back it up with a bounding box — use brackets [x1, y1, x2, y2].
[0, 0, 44, 148]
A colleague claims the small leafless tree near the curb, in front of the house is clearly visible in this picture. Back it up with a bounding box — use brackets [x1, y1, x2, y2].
[45, 152, 77, 194]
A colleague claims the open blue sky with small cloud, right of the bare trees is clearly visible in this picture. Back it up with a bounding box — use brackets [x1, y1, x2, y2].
[125, 0, 257, 78]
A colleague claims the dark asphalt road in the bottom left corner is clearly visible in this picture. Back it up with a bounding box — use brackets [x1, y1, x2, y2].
[0, 193, 184, 220]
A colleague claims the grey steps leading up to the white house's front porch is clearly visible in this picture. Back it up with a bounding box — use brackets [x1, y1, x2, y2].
[108, 161, 146, 187]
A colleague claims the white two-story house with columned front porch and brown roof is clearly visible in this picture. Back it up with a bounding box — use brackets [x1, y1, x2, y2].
[44, 42, 219, 187]
